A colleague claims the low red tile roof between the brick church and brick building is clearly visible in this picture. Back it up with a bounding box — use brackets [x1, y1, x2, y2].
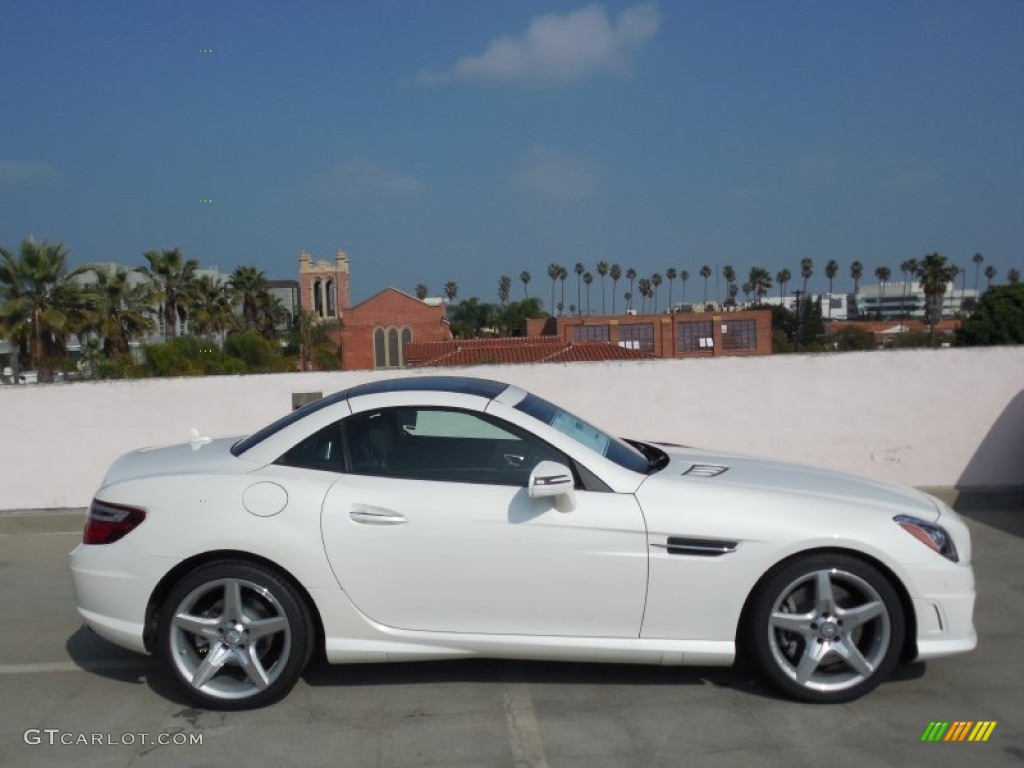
[406, 336, 654, 368]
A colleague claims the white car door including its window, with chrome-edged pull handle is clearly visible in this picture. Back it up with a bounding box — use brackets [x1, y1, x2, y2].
[322, 407, 647, 637]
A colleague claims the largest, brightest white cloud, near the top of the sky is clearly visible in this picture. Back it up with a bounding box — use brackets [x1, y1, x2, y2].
[418, 3, 660, 85]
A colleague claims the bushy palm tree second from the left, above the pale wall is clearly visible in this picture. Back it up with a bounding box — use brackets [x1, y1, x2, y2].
[84, 266, 157, 357]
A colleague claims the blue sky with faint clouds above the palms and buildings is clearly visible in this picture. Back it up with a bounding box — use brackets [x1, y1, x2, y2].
[0, 0, 1024, 302]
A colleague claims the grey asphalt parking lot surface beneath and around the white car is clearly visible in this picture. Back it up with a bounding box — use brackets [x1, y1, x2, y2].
[0, 506, 1024, 768]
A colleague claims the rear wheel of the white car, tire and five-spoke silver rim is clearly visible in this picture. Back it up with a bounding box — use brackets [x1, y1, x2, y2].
[157, 561, 313, 710]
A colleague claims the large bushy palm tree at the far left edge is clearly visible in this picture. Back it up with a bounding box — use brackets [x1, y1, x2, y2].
[0, 240, 88, 382]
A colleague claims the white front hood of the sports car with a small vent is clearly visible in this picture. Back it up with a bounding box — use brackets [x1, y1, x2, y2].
[656, 444, 940, 521]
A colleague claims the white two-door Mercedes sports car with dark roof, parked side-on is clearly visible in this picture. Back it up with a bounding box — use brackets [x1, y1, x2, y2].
[71, 377, 977, 709]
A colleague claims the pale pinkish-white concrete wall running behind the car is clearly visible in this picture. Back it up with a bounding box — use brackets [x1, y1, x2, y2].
[0, 347, 1024, 510]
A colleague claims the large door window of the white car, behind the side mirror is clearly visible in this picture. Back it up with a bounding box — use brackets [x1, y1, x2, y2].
[343, 408, 570, 485]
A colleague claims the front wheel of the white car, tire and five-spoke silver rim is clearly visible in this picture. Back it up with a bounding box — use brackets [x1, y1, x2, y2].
[741, 553, 906, 703]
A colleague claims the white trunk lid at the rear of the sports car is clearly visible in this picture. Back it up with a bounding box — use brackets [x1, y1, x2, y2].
[100, 437, 258, 487]
